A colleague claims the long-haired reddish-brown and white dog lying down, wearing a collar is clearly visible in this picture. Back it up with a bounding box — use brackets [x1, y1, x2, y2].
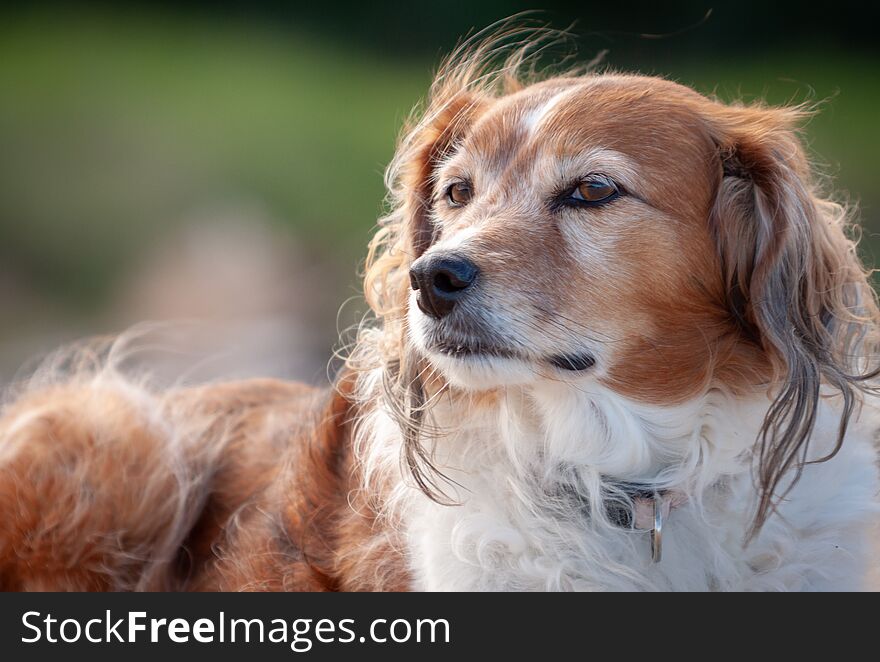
[0, 31, 880, 591]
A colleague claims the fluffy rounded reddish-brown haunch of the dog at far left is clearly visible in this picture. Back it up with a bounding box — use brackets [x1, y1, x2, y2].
[0, 387, 186, 590]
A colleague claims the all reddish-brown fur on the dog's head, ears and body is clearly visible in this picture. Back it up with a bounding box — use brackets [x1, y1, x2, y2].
[0, 32, 877, 590]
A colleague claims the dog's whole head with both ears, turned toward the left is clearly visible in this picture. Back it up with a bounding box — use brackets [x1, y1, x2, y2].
[367, 37, 877, 536]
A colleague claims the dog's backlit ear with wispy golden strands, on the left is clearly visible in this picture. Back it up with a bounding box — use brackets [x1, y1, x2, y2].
[364, 79, 489, 502]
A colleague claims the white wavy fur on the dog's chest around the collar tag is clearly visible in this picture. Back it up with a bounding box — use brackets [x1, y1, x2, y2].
[388, 387, 878, 590]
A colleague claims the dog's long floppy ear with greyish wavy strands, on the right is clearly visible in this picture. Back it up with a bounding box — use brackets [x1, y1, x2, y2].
[712, 107, 878, 533]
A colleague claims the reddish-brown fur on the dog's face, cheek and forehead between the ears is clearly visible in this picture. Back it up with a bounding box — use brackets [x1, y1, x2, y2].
[426, 76, 769, 404]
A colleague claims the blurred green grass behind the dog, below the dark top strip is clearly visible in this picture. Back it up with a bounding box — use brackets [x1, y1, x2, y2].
[0, 10, 880, 309]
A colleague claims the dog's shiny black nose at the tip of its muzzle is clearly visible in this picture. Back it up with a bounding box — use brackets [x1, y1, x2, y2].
[409, 253, 480, 319]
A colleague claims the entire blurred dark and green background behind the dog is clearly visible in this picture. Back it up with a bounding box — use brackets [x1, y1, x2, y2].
[0, 0, 880, 380]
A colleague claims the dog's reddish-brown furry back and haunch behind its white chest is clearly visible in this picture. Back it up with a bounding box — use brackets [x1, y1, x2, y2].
[0, 377, 382, 590]
